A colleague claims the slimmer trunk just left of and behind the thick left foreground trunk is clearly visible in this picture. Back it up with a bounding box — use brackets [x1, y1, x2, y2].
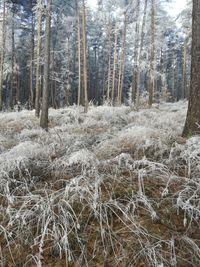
[35, 0, 42, 117]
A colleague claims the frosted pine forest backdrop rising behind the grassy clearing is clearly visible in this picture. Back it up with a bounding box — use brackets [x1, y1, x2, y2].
[0, 0, 191, 113]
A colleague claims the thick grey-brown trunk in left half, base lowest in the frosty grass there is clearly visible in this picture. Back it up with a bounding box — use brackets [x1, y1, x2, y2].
[40, 0, 52, 130]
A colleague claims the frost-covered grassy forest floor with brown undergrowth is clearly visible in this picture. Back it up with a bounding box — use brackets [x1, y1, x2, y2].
[0, 102, 200, 267]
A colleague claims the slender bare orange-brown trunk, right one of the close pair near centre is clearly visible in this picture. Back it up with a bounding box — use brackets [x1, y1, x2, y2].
[83, 0, 88, 112]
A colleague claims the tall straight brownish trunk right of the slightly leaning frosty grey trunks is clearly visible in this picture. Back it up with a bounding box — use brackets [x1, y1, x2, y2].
[149, 0, 156, 107]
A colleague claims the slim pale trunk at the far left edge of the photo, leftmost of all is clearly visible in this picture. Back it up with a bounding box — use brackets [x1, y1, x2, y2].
[0, 0, 6, 110]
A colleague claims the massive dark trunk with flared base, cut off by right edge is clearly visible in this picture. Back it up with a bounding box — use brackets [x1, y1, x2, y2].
[183, 0, 200, 136]
